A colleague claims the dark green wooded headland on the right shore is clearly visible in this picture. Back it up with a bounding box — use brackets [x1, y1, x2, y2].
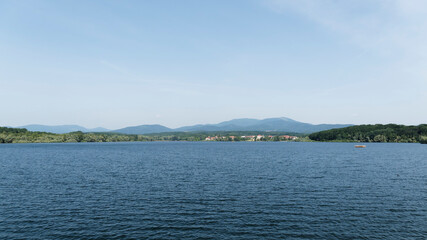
[309, 124, 427, 143]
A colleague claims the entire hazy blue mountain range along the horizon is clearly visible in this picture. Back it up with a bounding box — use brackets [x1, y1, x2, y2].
[21, 117, 351, 134]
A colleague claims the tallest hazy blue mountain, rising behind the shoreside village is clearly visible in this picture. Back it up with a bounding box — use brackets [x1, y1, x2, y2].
[174, 117, 351, 133]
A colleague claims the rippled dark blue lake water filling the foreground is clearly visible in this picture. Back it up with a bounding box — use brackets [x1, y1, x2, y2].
[0, 142, 427, 239]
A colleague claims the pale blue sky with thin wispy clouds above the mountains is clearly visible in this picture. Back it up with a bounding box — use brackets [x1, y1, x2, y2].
[0, 0, 427, 129]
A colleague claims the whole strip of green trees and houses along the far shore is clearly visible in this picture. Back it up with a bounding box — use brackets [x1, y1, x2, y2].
[0, 124, 427, 144]
